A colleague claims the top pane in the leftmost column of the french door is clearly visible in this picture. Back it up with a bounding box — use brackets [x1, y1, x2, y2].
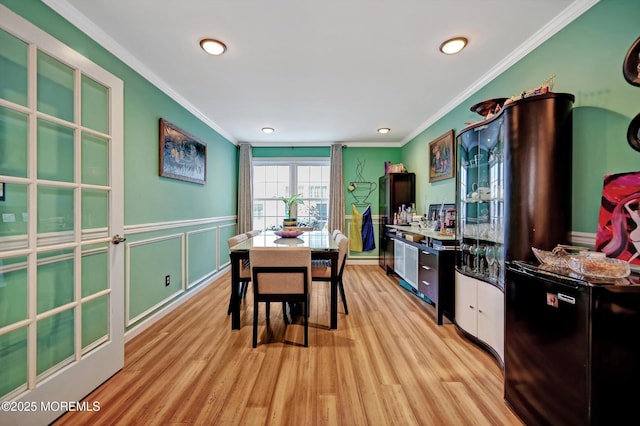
[0, 30, 28, 105]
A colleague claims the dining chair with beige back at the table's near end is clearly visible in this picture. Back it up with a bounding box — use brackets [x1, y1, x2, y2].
[249, 247, 311, 348]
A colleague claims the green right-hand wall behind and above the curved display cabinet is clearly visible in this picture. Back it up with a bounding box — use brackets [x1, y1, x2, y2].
[402, 0, 640, 233]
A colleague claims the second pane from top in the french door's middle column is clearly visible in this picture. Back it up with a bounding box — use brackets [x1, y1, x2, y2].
[38, 120, 73, 182]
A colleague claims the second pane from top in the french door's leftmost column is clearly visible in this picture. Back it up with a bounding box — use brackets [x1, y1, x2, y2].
[0, 107, 28, 177]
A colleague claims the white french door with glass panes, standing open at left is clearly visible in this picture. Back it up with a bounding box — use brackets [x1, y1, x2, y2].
[0, 5, 124, 425]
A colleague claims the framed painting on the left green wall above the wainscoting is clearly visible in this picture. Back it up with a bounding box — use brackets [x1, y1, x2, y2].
[160, 118, 207, 184]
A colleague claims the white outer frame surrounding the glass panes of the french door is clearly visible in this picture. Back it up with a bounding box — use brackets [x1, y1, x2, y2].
[0, 4, 125, 425]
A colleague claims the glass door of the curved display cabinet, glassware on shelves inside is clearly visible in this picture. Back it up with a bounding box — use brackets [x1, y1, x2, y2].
[457, 116, 505, 288]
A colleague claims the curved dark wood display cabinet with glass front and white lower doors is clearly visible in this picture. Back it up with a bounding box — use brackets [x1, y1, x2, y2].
[455, 93, 574, 361]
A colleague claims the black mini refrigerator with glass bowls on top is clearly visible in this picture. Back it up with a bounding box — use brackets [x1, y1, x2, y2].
[504, 261, 640, 426]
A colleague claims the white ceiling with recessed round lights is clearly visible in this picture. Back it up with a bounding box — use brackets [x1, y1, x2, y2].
[43, 0, 598, 146]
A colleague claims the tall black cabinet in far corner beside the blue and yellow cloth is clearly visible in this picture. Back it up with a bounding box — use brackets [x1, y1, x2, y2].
[378, 173, 416, 274]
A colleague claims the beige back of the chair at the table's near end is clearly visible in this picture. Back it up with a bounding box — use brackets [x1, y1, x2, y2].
[249, 247, 311, 297]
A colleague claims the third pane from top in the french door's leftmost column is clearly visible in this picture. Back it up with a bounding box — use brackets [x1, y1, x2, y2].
[0, 183, 28, 251]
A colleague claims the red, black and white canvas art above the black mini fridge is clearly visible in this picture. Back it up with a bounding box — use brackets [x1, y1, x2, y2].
[595, 172, 640, 270]
